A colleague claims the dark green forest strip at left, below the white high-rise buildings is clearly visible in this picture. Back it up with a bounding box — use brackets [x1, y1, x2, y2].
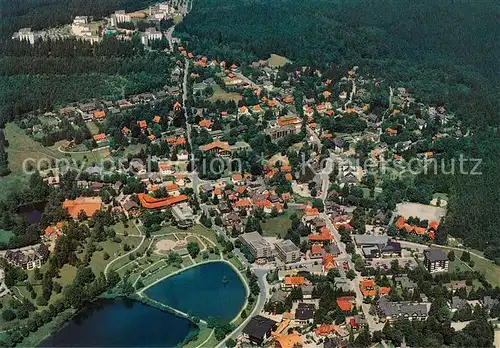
[0, 38, 172, 124]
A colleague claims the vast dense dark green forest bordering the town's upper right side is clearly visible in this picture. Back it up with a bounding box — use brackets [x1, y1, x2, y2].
[176, 0, 500, 263]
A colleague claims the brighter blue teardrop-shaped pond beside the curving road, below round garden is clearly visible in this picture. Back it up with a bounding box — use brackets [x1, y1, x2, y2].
[146, 262, 246, 321]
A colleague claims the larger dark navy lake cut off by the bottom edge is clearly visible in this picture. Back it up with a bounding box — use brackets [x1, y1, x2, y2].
[40, 299, 197, 347]
